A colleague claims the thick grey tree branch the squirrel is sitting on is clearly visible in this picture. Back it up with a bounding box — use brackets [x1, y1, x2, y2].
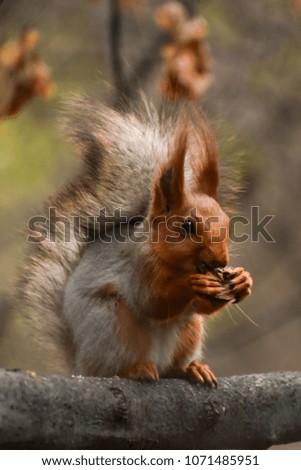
[0, 370, 301, 449]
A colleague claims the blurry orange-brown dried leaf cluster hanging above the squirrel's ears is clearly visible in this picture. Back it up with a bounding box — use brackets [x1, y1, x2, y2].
[155, 2, 212, 101]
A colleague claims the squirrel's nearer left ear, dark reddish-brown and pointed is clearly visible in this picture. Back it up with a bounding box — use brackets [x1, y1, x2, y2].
[152, 123, 187, 215]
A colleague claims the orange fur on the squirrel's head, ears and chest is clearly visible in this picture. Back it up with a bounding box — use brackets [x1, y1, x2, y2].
[142, 117, 229, 322]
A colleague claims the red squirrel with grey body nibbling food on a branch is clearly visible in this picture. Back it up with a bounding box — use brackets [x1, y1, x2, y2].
[22, 99, 252, 385]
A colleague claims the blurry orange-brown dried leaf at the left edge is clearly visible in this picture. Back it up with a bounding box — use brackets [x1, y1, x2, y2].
[0, 30, 53, 117]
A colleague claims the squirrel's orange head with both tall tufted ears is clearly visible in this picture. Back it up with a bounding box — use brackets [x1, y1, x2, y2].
[150, 115, 229, 272]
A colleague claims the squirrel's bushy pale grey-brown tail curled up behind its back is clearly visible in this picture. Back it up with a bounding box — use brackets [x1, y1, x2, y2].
[18, 98, 167, 371]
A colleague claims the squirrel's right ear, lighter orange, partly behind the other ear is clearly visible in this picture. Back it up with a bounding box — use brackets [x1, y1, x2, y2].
[189, 122, 219, 199]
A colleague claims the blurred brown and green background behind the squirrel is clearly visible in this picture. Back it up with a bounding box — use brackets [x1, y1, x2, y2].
[0, 0, 301, 448]
